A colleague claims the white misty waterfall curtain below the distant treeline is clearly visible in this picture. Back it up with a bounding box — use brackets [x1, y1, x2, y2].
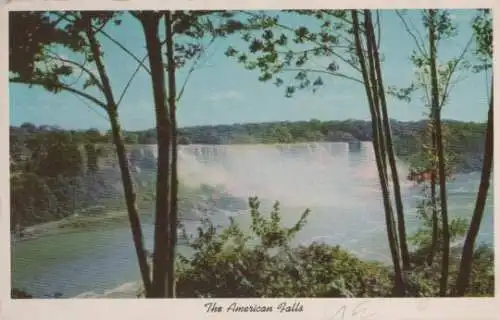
[179, 142, 414, 208]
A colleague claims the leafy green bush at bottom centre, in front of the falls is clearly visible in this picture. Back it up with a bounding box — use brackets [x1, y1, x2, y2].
[177, 198, 392, 298]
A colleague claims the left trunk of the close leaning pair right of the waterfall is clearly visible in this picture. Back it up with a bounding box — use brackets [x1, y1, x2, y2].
[351, 10, 404, 296]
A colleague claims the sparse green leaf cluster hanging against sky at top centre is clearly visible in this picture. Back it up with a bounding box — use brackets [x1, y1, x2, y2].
[221, 10, 355, 97]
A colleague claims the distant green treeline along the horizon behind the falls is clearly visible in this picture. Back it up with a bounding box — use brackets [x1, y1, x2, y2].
[10, 119, 486, 171]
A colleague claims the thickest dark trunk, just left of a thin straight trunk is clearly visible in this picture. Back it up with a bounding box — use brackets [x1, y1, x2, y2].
[142, 12, 173, 298]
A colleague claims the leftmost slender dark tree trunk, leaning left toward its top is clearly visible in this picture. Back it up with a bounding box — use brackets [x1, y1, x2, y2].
[87, 17, 151, 294]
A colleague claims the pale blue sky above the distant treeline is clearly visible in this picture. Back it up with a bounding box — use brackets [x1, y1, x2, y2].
[9, 10, 487, 130]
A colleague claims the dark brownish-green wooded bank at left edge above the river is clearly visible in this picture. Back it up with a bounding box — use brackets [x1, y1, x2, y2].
[10, 124, 146, 231]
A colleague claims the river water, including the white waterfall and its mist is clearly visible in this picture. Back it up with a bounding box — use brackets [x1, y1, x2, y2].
[11, 142, 493, 297]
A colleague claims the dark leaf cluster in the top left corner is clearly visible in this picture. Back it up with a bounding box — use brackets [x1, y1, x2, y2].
[9, 11, 120, 97]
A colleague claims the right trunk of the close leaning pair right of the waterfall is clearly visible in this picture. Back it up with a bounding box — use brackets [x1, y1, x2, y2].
[365, 10, 410, 270]
